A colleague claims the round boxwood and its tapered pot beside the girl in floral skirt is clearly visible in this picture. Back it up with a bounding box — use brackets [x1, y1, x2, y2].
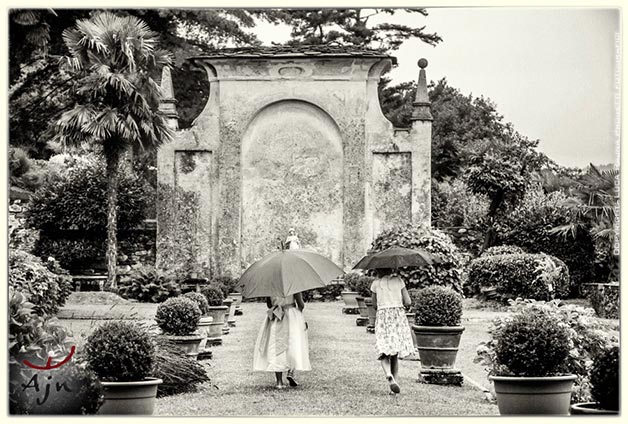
[412, 285, 464, 369]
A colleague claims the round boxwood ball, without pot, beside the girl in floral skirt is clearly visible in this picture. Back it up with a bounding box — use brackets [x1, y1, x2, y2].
[412, 286, 462, 327]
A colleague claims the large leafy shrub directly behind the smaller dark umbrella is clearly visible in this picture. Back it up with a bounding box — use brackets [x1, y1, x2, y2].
[371, 225, 462, 293]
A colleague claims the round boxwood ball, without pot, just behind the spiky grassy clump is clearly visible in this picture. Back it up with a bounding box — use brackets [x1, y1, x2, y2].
[155, 296, 201, 336]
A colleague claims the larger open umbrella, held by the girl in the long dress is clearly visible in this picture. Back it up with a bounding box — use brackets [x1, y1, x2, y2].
[238, 249, 344, 298]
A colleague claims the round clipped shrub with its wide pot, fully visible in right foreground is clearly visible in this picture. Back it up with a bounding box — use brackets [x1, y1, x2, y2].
[489, 309, 576, 415]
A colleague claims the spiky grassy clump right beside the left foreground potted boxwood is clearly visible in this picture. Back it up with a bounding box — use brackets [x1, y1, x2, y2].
[152, 338, 210, 397]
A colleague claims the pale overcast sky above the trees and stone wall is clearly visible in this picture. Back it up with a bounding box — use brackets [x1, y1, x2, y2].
[255, 7, 621, 167]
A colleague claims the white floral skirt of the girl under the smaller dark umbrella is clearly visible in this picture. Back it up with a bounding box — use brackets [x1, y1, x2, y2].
[375, 308, 414, 359]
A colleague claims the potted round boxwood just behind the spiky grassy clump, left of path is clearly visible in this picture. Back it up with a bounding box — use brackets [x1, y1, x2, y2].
[155, 296, 203, 358]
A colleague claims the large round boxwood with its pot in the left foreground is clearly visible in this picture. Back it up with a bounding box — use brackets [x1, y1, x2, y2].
[83, 321, 162, 415]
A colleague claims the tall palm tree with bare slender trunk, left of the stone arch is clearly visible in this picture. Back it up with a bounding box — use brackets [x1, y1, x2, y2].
[56, 12, 172, 287]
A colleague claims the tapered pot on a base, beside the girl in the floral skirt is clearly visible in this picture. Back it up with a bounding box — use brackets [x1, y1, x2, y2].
[412, 325, 464, 368]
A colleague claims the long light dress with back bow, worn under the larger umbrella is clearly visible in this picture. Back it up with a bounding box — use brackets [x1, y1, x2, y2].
[253, 295, 311, 372]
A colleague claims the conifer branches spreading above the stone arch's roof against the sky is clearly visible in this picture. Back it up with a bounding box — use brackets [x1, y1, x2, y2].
[254, 8, 441, 51]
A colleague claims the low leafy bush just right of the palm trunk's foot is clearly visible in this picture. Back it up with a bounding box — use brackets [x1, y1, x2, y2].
[118, 266, 181, 303]
